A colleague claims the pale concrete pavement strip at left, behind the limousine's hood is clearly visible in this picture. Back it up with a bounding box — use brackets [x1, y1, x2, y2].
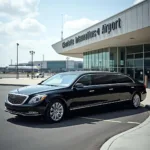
[0, 78, 46, 86]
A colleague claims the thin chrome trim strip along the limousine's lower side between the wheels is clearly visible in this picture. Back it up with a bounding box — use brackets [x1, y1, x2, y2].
[70, 100, 130, 110]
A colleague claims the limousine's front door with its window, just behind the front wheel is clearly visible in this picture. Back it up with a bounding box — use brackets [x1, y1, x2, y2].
[69, 74, 94, 109]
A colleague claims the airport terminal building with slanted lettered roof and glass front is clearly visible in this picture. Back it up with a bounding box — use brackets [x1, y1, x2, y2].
[52, 0, 150, 81]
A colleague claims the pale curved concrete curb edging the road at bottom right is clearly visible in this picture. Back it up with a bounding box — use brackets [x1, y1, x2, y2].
[100, 105, 150, 150]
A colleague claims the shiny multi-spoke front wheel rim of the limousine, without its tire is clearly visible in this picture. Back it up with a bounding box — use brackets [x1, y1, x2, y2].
[50, 102, 64, 121]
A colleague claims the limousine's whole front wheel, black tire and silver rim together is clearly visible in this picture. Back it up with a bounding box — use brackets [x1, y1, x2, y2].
[44, 99, 65, 123]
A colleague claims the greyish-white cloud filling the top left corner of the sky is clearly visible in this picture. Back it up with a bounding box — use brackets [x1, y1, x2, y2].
[0, 0, 40, 17]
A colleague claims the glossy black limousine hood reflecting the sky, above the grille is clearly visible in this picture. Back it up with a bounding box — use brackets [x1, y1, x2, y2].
[10, 85, 64, 95]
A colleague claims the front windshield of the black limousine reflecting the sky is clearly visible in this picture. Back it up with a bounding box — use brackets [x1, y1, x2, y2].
[42, 74, 78, 86]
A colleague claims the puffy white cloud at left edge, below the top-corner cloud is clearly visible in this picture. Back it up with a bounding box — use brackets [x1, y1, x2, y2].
[0, 18, 46, 36]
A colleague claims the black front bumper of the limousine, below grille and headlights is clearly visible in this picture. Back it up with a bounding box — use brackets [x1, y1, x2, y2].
[5, 103, 45, 116]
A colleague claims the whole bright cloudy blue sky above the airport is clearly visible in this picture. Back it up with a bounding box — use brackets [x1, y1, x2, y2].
[0, 0, 143, 67]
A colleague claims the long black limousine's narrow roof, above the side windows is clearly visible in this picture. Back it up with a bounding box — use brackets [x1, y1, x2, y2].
[60, 71, 121, 76]
